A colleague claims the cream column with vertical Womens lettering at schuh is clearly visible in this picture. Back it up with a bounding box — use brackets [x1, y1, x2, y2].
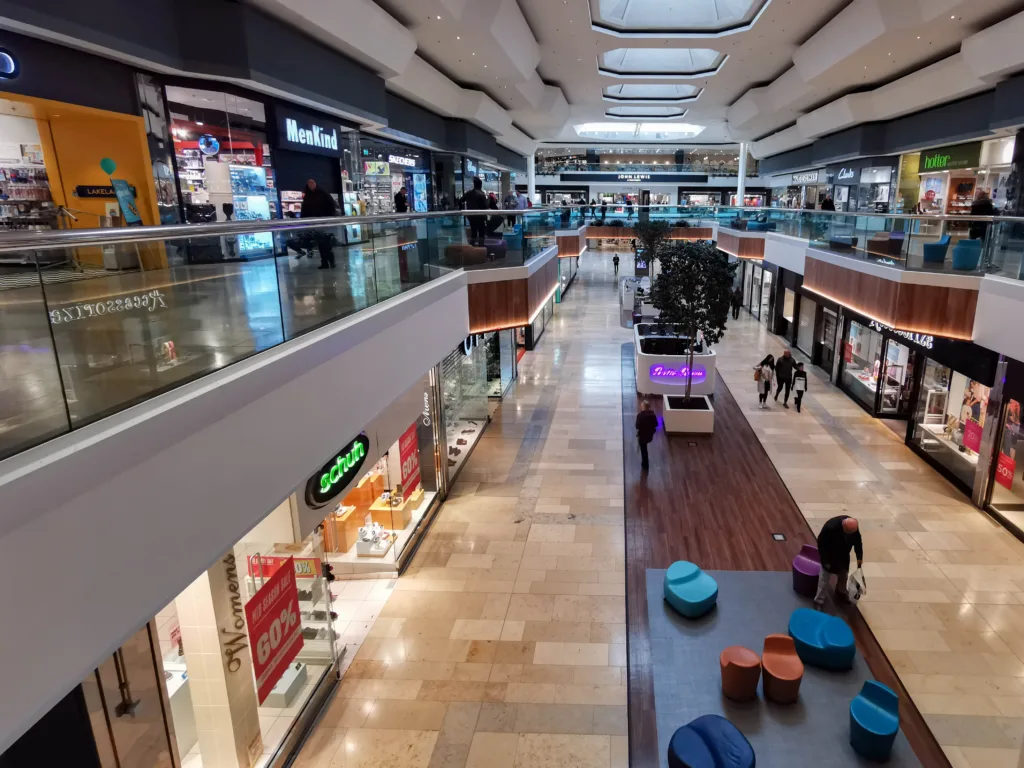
[175, 552, 263, 768]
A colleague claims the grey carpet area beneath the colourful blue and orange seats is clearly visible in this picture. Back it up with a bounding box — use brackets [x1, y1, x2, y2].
[647, 569, 921, 768]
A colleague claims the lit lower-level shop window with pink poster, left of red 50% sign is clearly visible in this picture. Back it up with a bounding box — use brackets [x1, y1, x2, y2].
[910, 359, 989, 488]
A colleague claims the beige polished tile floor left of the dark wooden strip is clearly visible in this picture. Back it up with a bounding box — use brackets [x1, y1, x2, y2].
[295, 253, 631, 768]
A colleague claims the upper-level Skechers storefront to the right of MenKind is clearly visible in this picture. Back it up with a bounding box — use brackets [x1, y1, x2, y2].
[359, 134, 433, 215]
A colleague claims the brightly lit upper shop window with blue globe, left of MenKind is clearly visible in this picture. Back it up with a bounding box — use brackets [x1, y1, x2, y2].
[166, 85, 281, 243]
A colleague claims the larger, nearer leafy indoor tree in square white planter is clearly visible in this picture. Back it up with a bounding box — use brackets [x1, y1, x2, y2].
[651, 240, 736, 401]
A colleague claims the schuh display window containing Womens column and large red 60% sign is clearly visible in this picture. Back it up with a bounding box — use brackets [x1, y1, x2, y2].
[155, 498, 335, 768]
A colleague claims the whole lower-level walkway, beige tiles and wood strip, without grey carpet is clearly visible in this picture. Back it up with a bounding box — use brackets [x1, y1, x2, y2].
[295, 252, 1024, 768]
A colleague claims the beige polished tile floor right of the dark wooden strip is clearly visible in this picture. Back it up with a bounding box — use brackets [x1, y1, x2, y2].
[718, 312, 1024, 768]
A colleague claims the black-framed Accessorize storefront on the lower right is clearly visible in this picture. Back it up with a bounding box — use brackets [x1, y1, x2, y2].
[839, 308, 998, 496]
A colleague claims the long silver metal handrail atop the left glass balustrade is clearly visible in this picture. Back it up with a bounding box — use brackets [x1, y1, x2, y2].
[0, 207, 561, 253]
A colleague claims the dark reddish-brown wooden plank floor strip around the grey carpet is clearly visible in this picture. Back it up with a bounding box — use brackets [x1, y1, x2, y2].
[622, 344, 949, 768]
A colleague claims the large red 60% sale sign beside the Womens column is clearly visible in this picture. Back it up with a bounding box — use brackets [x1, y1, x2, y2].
[246, 557, 302, 703]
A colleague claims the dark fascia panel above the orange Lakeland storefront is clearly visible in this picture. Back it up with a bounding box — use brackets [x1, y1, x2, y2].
[0, 32, 137, 115]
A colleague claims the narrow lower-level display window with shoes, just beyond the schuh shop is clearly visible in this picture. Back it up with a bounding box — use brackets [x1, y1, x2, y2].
[441, 335, 490, 479]
